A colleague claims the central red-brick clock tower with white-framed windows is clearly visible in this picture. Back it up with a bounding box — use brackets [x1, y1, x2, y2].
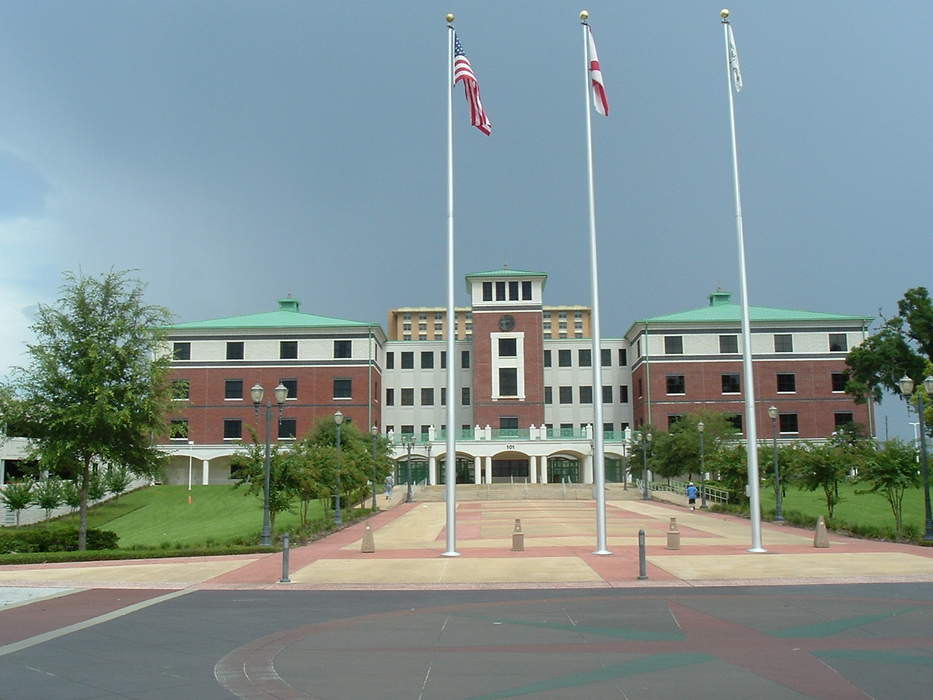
[466, 268, 547, 430]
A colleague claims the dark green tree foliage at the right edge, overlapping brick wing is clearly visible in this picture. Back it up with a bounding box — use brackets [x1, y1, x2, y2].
[846, 287, 933, 429]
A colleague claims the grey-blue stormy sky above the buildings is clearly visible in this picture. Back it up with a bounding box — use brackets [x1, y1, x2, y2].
[0, 0, 933, 434]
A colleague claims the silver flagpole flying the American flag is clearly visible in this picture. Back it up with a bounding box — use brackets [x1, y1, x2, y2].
[442, 13, 460, 557]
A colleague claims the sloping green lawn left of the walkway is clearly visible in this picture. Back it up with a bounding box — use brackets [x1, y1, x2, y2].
[55, 486, 321, 549]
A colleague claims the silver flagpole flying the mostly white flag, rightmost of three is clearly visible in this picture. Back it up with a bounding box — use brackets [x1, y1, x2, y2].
[719, 10, 768, 552]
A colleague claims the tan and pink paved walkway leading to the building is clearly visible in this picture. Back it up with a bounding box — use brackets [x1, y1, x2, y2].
[0, 494, 933, 592]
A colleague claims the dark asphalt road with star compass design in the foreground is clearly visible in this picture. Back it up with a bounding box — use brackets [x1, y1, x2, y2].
[0, 584, 933, 700]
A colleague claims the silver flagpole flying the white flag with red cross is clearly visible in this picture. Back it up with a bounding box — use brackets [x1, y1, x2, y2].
[580, 10, 612, 554]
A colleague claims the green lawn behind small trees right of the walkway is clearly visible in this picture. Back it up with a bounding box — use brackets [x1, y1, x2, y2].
[761, 484, 924, 532]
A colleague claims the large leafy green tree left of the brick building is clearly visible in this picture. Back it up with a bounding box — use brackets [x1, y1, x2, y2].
[17, 271, 170, 550]
